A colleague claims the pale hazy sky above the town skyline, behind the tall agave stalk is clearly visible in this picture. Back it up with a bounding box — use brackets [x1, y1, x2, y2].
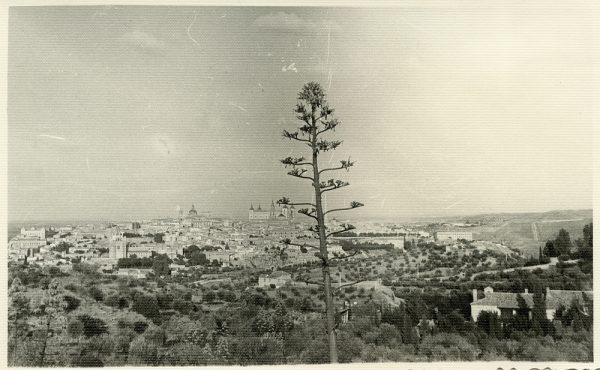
[8, 6, 599, 221]
